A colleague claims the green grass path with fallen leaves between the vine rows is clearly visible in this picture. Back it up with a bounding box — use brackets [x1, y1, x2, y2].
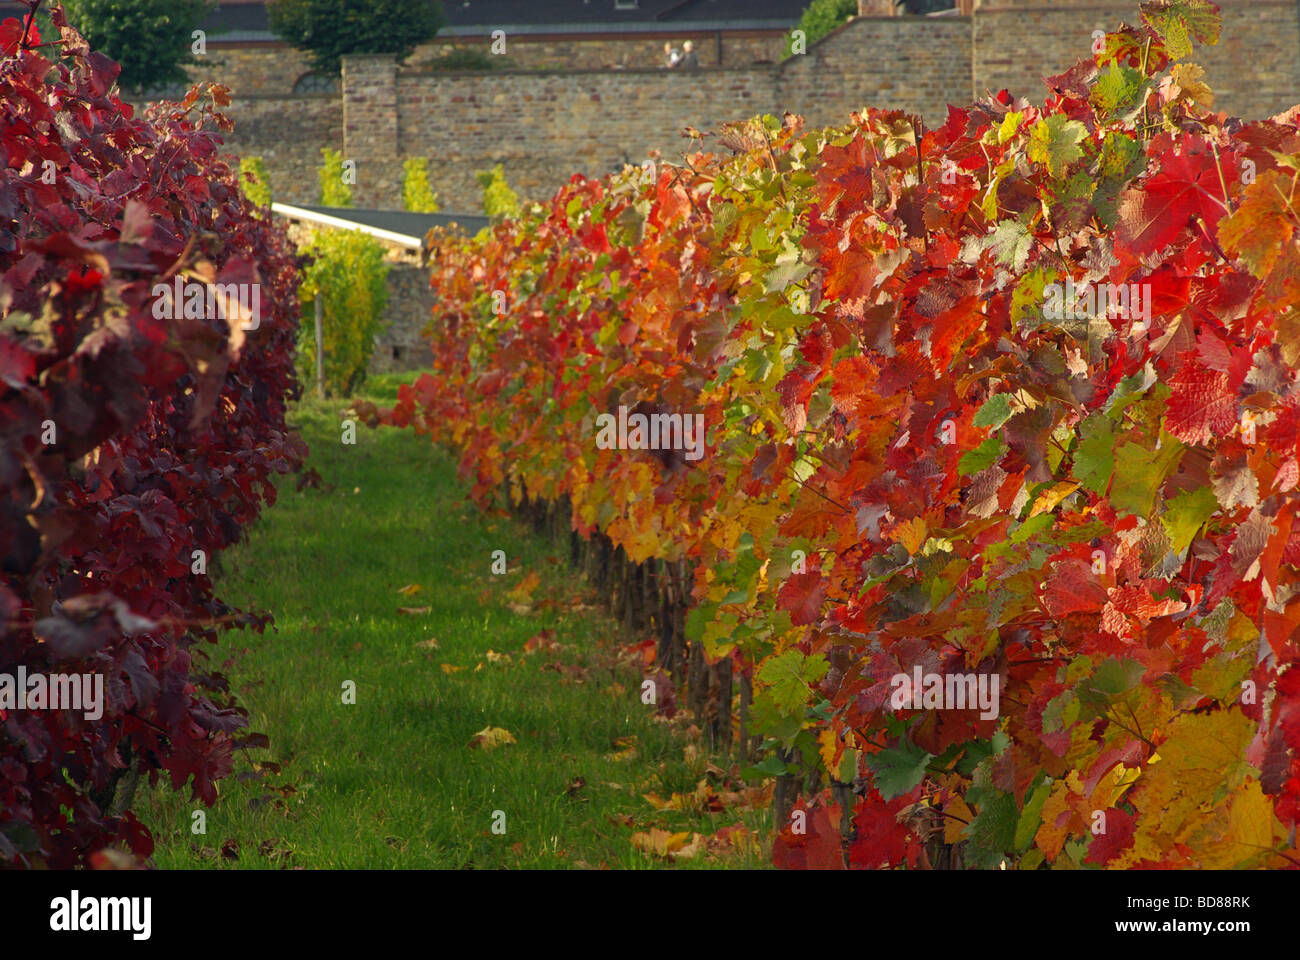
[135, 375, 771, 869]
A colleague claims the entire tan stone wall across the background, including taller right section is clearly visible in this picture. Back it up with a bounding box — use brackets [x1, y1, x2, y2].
[185, 0, 1300, 212]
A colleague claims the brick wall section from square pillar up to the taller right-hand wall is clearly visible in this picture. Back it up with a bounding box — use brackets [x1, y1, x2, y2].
[343, 17, 970, 211]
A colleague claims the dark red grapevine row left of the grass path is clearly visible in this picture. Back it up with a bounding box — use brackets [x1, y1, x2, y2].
[0, 8, 306, 868]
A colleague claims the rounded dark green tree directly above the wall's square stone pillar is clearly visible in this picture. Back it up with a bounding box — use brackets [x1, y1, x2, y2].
[267, 0, 446, 74]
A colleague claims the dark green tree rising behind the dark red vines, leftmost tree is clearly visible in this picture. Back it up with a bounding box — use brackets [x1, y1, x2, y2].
[64, 0, 213, 92]
